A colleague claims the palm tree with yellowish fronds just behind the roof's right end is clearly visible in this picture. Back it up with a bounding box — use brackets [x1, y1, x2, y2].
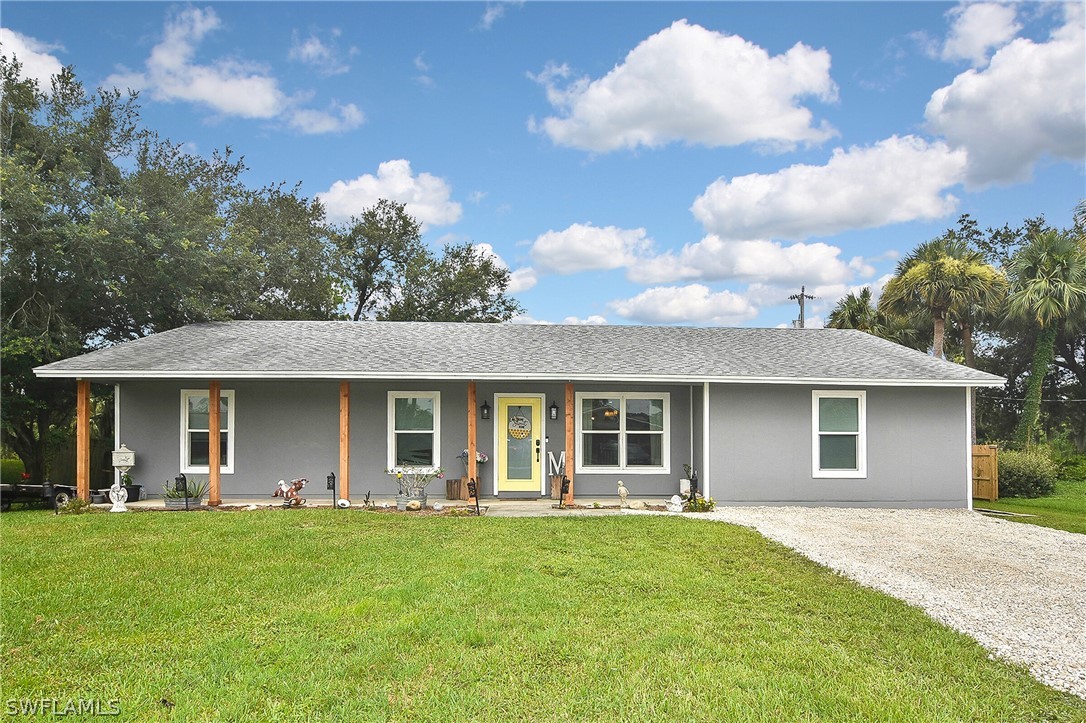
[879, 233, 1007, 360]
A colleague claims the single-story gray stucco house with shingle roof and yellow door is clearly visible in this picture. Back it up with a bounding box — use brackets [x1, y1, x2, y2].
[37, 321, 1003, 507]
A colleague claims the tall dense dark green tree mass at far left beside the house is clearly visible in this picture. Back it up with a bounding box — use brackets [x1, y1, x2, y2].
[0, 55, 340, 480]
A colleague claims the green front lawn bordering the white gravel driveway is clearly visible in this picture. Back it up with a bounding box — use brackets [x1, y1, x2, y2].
[0, 509, 1086, 722]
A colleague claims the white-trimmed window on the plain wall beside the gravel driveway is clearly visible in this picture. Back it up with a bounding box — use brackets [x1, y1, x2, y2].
[811, 391, 868, 478]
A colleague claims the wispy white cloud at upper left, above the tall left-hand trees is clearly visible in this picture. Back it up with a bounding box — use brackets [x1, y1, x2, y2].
[105, 7, 365, 134]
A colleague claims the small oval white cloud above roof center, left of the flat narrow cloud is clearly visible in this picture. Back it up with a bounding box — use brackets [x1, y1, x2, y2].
[531, 224, 652, 274]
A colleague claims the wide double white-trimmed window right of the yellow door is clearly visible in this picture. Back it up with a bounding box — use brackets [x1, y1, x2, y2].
[577, 392, 671, 474]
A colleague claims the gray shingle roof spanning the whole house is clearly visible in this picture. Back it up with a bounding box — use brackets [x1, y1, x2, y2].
[36, 321, 1003, 386]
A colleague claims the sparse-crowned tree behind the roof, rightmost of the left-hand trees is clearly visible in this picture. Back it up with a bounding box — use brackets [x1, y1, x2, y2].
[336, 199, 522, 321]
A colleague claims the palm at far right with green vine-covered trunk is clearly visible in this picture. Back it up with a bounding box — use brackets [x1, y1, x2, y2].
[1008, 230, 1086, 446]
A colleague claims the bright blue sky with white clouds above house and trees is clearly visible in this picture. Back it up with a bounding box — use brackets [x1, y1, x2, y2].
[0, 2, 1086, 327]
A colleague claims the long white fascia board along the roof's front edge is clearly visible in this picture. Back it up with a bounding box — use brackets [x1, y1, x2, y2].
[35, 367, 1006, 386]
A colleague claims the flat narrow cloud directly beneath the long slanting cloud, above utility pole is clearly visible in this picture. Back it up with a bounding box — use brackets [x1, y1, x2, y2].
[629, 234, 860, 283]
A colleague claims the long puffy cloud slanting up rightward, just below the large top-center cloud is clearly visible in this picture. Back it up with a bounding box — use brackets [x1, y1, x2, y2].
[691, 136, 965, 240]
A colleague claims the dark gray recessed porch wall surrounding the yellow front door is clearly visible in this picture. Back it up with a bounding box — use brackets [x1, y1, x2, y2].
[121, 379, 700, 499]
